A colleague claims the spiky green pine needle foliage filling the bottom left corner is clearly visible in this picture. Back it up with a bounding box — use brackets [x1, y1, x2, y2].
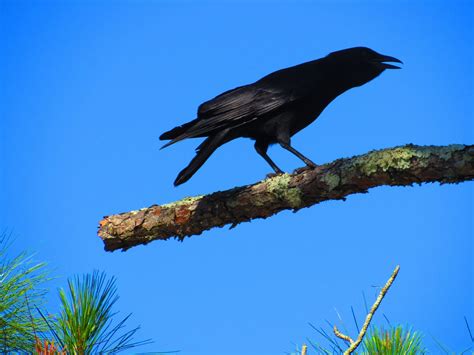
[0, 233, 150, 355]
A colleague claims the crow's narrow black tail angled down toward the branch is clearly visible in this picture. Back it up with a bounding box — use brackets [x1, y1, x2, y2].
[174, 130, 228, 186]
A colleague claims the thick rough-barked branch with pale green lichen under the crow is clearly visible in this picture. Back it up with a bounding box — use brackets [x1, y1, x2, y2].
[98, 144, 474, 251]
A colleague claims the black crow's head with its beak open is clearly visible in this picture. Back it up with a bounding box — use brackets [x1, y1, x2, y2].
[326, 47, 403, 86]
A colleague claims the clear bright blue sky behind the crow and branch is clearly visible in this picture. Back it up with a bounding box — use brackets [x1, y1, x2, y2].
[0, 0, 474, 355]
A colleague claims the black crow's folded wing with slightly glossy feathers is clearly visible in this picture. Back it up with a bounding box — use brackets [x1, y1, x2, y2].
[165, 85, 295, 146]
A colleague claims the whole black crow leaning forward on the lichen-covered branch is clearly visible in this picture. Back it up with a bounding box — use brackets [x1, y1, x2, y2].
[160, 47, 402, 186]
